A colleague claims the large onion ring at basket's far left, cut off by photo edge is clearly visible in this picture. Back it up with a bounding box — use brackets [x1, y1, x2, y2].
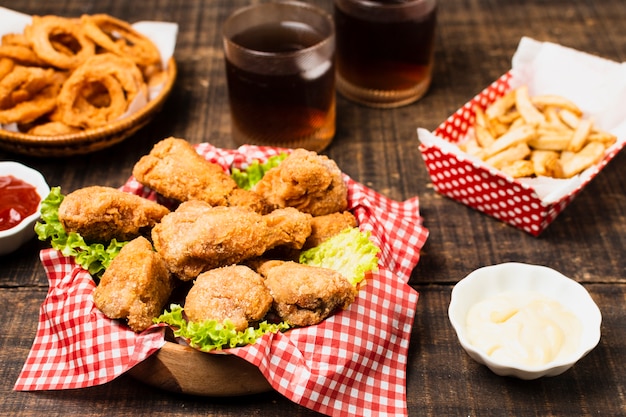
[0, 66, 62, 124]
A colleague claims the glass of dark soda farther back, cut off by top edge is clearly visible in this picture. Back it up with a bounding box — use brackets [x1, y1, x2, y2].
[334, 0, 437, 107]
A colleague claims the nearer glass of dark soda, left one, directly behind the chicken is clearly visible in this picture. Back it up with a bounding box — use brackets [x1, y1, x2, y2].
[222, 1, 335, 152]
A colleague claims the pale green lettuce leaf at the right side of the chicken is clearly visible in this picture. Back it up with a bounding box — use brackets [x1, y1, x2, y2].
[300, 227, 380, 285]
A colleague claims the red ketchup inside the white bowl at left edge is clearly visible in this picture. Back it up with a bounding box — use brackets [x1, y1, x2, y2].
[0, 175, 41, 230]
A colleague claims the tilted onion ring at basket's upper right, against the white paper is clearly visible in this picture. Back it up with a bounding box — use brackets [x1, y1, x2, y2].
[81, 14, 161, 66]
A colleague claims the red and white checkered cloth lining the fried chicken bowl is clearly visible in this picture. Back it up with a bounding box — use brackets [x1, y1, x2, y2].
[15, 144, 428, 416]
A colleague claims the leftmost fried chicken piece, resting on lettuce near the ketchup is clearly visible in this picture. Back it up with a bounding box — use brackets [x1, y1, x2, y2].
[59, 186, 170, 242]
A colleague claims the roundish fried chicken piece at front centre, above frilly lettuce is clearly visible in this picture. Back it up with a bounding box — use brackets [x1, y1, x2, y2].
[185, 265, 272, 331]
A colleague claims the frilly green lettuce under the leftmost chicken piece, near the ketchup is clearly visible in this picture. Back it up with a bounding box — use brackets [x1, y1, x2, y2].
[35, 187, 127, 278]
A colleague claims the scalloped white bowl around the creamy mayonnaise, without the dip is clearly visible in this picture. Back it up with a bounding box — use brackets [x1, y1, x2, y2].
[448, 262, 602, 380]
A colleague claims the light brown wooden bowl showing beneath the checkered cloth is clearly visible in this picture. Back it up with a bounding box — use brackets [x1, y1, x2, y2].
[128, 342, 272, 397]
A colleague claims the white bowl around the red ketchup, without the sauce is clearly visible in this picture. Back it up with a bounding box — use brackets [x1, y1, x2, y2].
[0, 161, 50, 256]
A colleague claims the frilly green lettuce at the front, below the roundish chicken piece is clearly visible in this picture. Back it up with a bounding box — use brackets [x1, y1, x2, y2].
[154, 304, 289, 352]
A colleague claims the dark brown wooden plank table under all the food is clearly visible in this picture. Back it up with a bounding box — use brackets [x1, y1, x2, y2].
[0, 0, 626, 417]
